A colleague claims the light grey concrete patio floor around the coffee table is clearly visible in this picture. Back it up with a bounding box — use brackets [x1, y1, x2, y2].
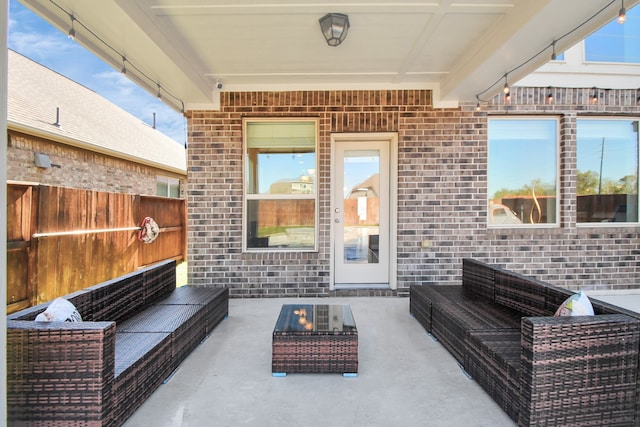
[125, 298, 515, 427]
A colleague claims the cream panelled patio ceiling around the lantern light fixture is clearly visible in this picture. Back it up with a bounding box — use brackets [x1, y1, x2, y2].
[21, 0, 640, 110]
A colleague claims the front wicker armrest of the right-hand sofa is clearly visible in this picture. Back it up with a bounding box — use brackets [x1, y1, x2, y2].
[519, 314, 640, 426]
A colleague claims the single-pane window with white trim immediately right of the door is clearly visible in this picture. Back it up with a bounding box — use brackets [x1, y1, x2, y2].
[487, 117, 559, 227]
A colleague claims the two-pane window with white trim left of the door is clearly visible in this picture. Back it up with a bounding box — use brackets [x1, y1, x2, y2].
[244, 119, 318, 251]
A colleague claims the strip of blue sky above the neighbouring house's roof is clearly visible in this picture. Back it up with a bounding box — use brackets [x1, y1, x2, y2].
[8, 0, 186, 145]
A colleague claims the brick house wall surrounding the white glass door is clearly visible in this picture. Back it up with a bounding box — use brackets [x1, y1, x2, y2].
[188, 88, 640, 297]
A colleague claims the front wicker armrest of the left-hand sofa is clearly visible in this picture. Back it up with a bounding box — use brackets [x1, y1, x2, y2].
[7, 320, 116, 426]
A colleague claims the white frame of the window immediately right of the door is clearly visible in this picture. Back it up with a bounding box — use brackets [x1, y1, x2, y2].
[485, 115, 562, 230]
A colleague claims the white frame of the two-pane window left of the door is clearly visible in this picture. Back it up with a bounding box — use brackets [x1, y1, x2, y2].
[242, 117, 320, 253]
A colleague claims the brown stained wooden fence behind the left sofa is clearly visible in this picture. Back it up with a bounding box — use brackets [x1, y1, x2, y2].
[7, 183, 187, 313]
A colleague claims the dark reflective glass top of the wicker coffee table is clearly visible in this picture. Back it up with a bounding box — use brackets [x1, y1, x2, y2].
[273, 304, 357, 333]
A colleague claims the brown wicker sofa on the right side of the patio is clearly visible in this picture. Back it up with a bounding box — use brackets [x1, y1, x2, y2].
[409, 259, 640, 426]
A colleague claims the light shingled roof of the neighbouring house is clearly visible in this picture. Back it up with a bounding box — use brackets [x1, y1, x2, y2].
[7, 50, 186, 174]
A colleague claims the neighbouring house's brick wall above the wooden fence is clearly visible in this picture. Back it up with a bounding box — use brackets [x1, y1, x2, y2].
[7, 131, 185, 195]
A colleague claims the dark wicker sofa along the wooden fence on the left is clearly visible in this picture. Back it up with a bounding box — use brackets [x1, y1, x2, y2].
[7, 261, 229, 427]
